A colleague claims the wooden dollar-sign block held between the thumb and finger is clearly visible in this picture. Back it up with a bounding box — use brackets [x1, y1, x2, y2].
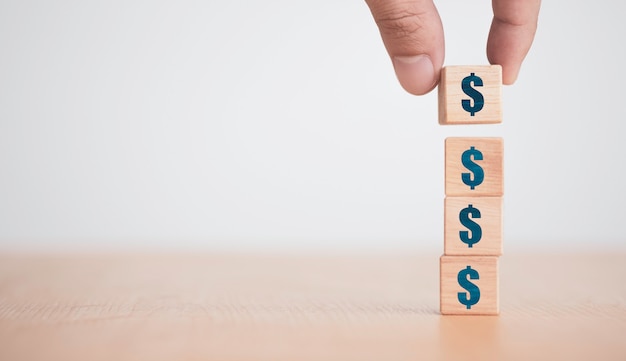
[438, 65, 502, 125]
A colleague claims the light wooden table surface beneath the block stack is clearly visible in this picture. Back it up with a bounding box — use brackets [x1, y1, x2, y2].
[0, 252, 626, 361]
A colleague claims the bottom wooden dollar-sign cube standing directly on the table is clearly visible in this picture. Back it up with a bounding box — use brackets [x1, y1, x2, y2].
[439, 256, 500, 315]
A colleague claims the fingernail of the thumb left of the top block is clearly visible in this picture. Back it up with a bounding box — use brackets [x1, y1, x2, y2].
[393, 54, 436, 95]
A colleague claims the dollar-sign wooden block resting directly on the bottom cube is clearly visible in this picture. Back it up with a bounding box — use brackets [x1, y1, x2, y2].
[443, 197, 502, 256]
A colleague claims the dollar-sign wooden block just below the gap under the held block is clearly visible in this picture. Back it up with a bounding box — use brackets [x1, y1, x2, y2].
[445, 138, 504, 197]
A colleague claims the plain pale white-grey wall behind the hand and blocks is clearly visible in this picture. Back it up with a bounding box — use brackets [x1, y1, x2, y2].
[0, 0, 626, 251]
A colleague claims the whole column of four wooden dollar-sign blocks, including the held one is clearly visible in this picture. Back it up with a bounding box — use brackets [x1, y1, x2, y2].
[439, 65, 503, 315]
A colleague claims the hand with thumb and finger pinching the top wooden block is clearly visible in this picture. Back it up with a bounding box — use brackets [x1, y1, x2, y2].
[365, 0, 541, 95]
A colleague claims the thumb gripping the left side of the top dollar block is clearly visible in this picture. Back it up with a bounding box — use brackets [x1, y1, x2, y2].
[365, 0, 444, 95]
